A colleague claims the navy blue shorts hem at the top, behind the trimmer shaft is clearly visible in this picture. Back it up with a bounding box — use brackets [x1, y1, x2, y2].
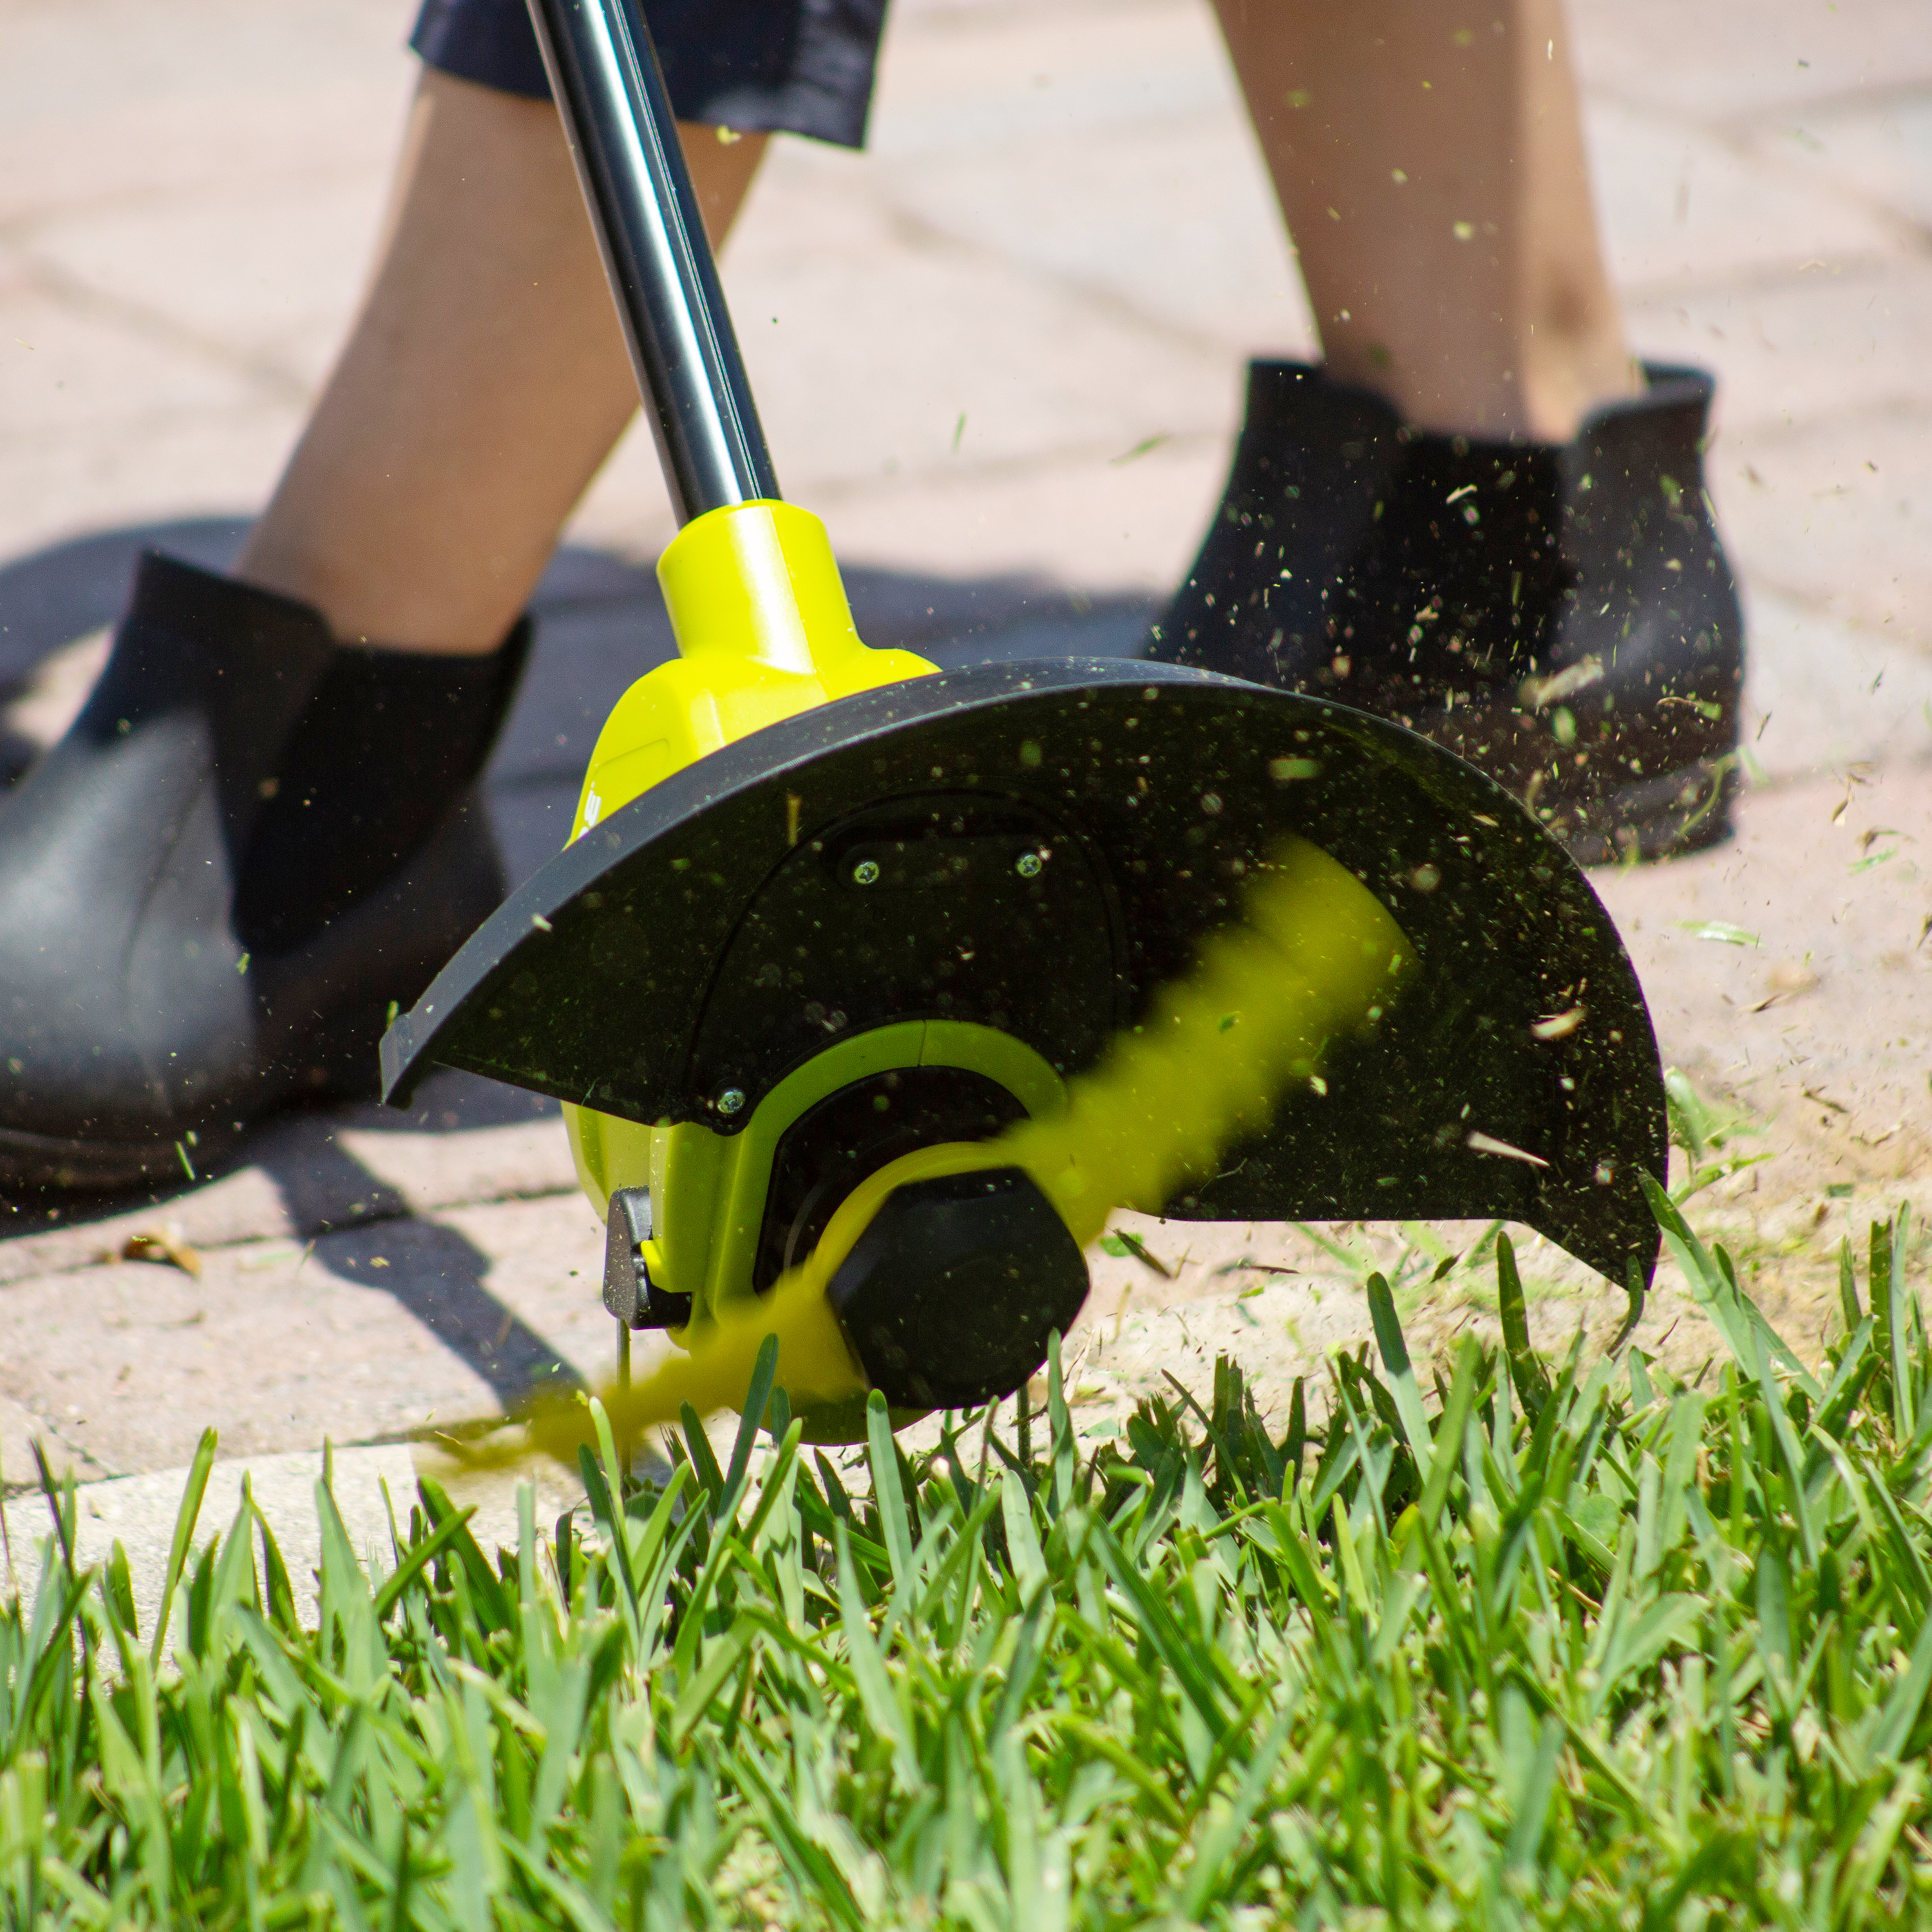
[410, 0, 885, 147]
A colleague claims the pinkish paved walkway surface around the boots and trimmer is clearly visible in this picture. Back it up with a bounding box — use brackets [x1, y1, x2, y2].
[0, 0, 1932, 1538]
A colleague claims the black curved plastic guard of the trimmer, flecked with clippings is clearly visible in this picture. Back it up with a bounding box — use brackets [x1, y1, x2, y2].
[383, 659, 1667, 1285]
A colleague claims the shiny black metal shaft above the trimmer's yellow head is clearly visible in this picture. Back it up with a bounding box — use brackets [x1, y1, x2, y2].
[529, 0, 779, 524]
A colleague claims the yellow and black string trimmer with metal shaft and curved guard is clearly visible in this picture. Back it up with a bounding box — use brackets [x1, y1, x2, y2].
[383, 0, 1665, 1439]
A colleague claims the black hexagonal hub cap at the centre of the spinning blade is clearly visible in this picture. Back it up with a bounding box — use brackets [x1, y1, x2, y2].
[827, 1167, 1088, 1408]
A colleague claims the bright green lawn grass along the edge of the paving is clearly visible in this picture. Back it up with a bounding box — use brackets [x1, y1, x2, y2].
[0, 1196, 1932, 1932]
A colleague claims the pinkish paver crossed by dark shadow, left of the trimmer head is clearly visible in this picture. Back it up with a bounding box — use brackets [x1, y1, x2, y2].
[0, 1194, 612, 1472]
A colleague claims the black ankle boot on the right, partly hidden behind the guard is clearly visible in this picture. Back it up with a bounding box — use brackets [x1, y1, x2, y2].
[1148, 361, 1745, 864]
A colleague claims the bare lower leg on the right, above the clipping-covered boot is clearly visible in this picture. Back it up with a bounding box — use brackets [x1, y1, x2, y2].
[1215, 0, 1642, 442]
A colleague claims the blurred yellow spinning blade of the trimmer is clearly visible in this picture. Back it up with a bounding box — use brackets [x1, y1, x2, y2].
[498, 838, 1408, 1464]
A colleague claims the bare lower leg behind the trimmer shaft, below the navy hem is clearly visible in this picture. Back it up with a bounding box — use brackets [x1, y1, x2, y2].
[236, 70, 765, 653]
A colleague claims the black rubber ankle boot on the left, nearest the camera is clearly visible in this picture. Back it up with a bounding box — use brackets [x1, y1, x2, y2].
[0, 554, 529, 1188]
